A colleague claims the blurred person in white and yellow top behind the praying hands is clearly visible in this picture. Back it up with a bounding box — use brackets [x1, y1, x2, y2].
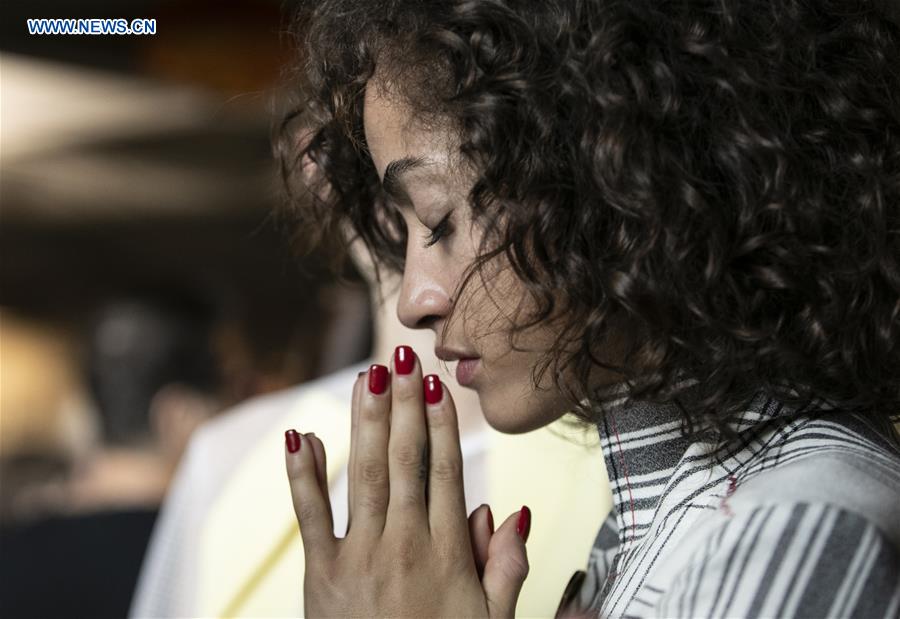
[130, 235, 611, 619]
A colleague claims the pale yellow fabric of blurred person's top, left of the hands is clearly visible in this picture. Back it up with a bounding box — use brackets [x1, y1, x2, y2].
[195, 389, 350, 617]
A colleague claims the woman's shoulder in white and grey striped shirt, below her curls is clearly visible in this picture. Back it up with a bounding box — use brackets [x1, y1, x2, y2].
[651, 412, 900, 617]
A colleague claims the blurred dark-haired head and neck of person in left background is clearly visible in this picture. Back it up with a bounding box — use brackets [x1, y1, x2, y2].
[71, 298, 220, 510]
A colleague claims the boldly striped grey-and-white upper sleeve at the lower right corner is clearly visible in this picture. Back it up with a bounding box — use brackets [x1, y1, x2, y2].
[655, 501, 900, 617]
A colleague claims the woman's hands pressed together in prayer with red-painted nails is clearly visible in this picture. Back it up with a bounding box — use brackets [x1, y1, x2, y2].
[285, 347, 530, 617]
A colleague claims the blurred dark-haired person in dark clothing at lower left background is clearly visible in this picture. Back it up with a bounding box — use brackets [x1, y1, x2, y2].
[0, 297, 220, 617]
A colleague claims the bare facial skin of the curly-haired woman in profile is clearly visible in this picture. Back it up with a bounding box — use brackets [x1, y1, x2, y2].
[363, 81, 566, 434]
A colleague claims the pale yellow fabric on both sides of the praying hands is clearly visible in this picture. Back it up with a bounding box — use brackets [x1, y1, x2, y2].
[196, 391, 610, 617]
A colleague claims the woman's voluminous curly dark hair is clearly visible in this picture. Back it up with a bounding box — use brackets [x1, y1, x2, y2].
[276, 0, 900, 434]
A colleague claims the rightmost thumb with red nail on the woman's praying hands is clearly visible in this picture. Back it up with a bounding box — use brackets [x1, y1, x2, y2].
[481, 505, 531, 617]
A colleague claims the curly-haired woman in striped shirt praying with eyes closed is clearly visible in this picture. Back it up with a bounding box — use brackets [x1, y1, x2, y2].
[281, 0, 900, 616]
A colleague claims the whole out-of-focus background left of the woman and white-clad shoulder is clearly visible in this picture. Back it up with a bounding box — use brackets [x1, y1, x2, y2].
[0, 0, 371, 617]
